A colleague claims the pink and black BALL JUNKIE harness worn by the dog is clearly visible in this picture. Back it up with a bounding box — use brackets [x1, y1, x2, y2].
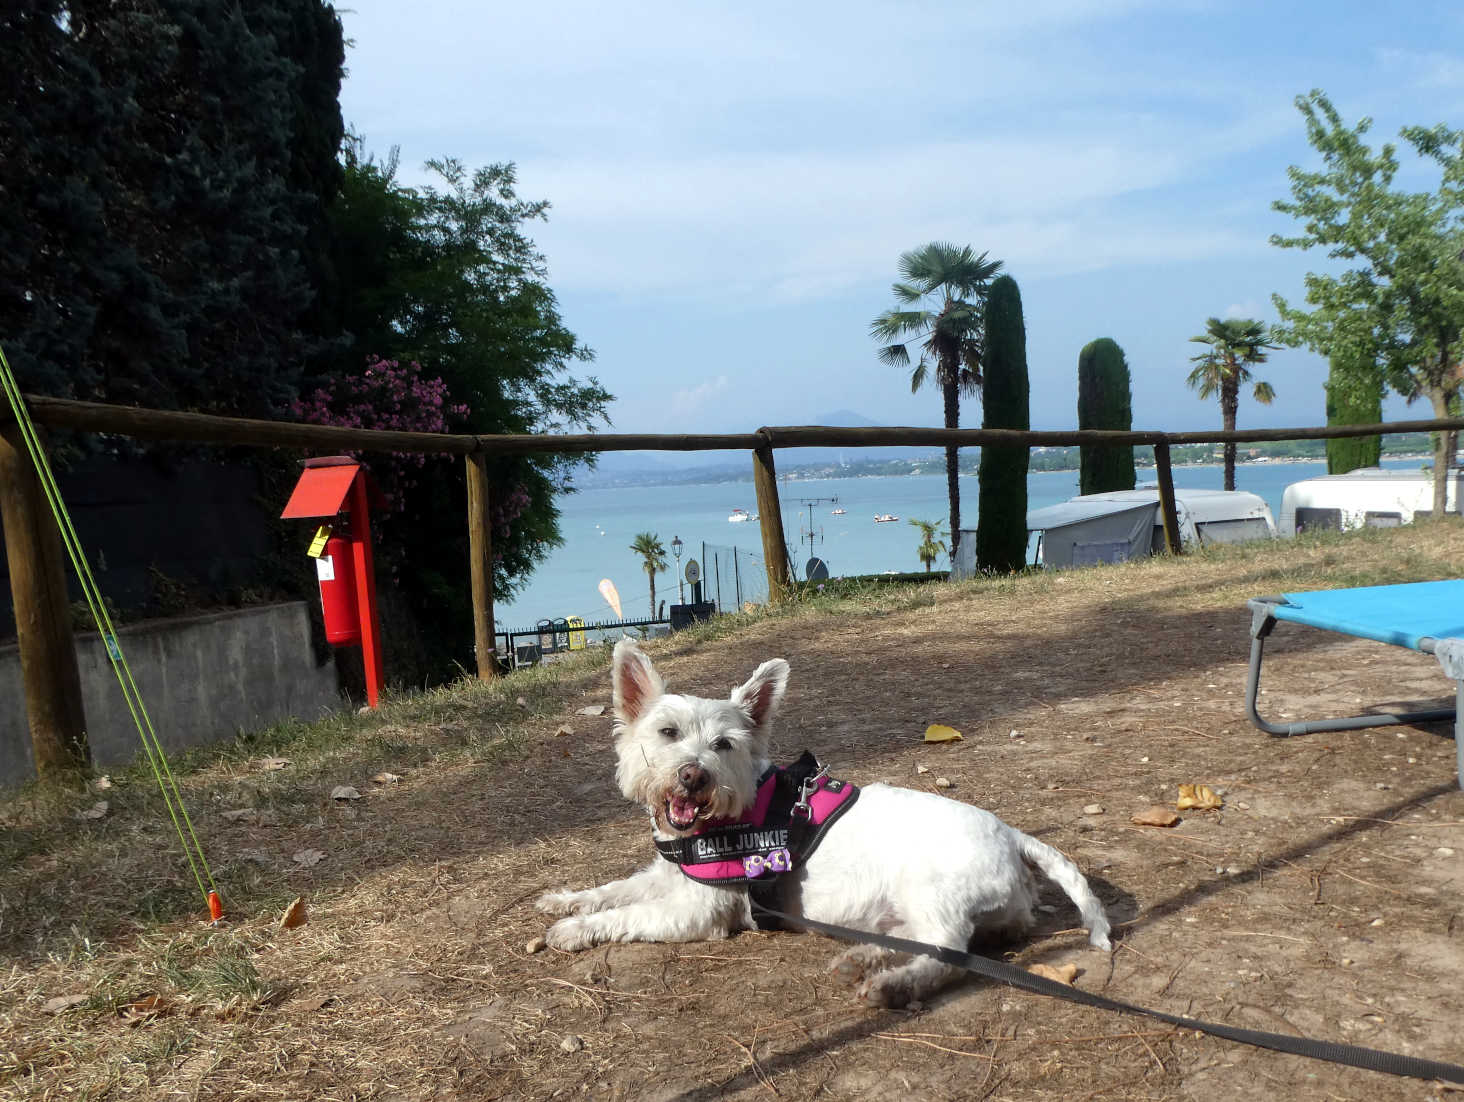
[656, 751, 859, 929]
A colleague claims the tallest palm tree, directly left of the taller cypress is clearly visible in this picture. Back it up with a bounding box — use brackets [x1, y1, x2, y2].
[870, 241, 1001, 559]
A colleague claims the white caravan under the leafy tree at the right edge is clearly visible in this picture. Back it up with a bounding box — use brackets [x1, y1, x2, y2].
[1277, 467, 1464, 536]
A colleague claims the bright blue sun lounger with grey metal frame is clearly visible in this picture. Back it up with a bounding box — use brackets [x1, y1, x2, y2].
[1246, 580, 1464, 789]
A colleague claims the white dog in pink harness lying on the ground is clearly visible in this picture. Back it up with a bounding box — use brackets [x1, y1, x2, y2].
[537, 640, 1110, 1007]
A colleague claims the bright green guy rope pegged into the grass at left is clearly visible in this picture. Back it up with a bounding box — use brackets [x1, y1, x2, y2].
[0, 348, 223, 919]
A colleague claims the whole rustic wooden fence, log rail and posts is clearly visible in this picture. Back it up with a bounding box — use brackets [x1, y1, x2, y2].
[0, 395, 1464, 777]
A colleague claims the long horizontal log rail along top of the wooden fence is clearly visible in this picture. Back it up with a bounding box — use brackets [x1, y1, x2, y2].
[11, 395, 1464, 455]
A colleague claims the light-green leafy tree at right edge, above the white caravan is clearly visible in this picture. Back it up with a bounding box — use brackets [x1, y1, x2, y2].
[1271, 91, 1464, 515]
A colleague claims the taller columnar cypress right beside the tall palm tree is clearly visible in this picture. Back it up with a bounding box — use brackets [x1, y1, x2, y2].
[976, 275, 1032, 574]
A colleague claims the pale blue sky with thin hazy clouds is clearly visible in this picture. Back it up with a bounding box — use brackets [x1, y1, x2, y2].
[341, 0, 1464, 447]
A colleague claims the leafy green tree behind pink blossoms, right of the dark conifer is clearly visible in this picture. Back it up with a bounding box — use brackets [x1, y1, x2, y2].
[320, 144, 610, 678]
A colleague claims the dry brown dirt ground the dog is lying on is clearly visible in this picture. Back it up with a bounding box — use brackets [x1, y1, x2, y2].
[0, 533, 1464, 1102]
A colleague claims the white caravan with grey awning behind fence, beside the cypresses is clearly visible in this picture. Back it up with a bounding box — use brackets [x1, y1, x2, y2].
[955, 484, 1277, 577]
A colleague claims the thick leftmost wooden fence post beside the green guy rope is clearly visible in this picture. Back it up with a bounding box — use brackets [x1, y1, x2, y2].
[0, 421, 91, 780]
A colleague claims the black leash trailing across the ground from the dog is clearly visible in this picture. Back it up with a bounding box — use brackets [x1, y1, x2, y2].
[752, 899, 1464, 1083]
